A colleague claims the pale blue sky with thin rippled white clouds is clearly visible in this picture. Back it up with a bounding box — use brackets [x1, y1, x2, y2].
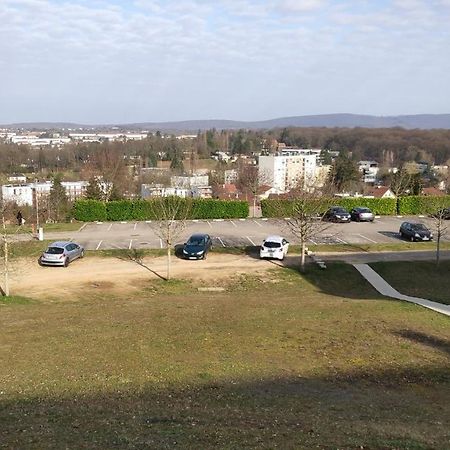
[0, 0, 450, 124]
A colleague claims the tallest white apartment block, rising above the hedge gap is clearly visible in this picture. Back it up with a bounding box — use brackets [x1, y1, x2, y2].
[258, 149, 317, 193]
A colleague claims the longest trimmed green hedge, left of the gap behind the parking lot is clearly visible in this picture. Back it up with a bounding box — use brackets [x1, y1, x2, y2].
[73, 197, 249, 222]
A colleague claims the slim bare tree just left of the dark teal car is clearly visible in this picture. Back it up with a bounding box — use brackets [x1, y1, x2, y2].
[149, 196, 192, 280]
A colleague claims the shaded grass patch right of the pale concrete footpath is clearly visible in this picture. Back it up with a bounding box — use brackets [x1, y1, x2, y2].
[370, 260, 450, 305]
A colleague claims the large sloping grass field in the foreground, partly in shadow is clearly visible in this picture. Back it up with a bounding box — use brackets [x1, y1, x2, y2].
[0, 263, 450, 449]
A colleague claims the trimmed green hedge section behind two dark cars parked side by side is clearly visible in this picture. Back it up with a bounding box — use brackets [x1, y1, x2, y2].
[261, 197, 397, 217]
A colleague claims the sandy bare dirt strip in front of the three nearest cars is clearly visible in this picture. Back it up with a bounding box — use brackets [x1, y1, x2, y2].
[11, 254, 286, 298]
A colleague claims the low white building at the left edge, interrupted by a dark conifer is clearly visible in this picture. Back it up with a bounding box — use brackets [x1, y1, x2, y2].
[2, 181, 89, 206]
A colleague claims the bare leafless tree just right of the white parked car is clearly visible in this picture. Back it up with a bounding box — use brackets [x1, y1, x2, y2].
[270, 184, 333, 272]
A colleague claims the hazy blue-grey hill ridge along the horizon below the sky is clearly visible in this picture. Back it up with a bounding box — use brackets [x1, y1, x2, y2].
[3, 114, 450, 133]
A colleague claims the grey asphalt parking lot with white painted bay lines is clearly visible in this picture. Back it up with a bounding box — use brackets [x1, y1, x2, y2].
[41, 216, 449, 250]
